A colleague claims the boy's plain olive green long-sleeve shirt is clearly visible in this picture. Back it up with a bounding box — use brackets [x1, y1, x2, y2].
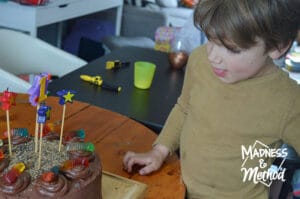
[155, 46, 300, 199]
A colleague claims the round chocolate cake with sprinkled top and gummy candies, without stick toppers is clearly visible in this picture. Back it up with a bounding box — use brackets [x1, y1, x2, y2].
[0, 135, 102, 199]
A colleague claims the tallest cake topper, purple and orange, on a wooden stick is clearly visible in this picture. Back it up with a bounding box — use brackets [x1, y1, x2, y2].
[28, 73, 50, 153]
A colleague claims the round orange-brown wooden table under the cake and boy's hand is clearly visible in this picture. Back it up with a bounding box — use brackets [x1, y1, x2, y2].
[0, 95, 185, 199]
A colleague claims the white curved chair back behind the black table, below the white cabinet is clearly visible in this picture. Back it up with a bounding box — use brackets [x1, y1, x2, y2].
[0, 29, 87, 78]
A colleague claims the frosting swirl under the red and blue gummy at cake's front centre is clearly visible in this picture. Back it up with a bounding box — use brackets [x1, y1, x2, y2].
[35, 175, 69, 198]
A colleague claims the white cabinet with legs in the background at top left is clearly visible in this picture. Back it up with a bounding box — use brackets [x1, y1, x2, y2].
[0, 0, 123, 45]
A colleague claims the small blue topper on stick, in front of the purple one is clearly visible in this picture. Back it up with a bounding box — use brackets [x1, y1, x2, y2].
[37, 103, 51, 168]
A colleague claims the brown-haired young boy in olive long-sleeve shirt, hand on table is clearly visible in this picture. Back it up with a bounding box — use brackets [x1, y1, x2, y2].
[124, 0, 300, 199]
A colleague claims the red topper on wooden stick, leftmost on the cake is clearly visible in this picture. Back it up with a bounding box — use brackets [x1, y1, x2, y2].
[0, 89, 17, 156]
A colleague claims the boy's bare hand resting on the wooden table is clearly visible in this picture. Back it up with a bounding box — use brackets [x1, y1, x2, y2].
[123, 145, 169, 175]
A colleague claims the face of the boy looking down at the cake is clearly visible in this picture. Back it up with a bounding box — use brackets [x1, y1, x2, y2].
[207, 39, 276, 83]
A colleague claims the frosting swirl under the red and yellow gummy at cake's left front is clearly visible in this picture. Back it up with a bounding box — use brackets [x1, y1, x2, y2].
[0, 172, 31, 195]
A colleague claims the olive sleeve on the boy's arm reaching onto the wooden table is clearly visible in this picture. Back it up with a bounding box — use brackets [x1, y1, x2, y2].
[154, 47, 199, 153]
